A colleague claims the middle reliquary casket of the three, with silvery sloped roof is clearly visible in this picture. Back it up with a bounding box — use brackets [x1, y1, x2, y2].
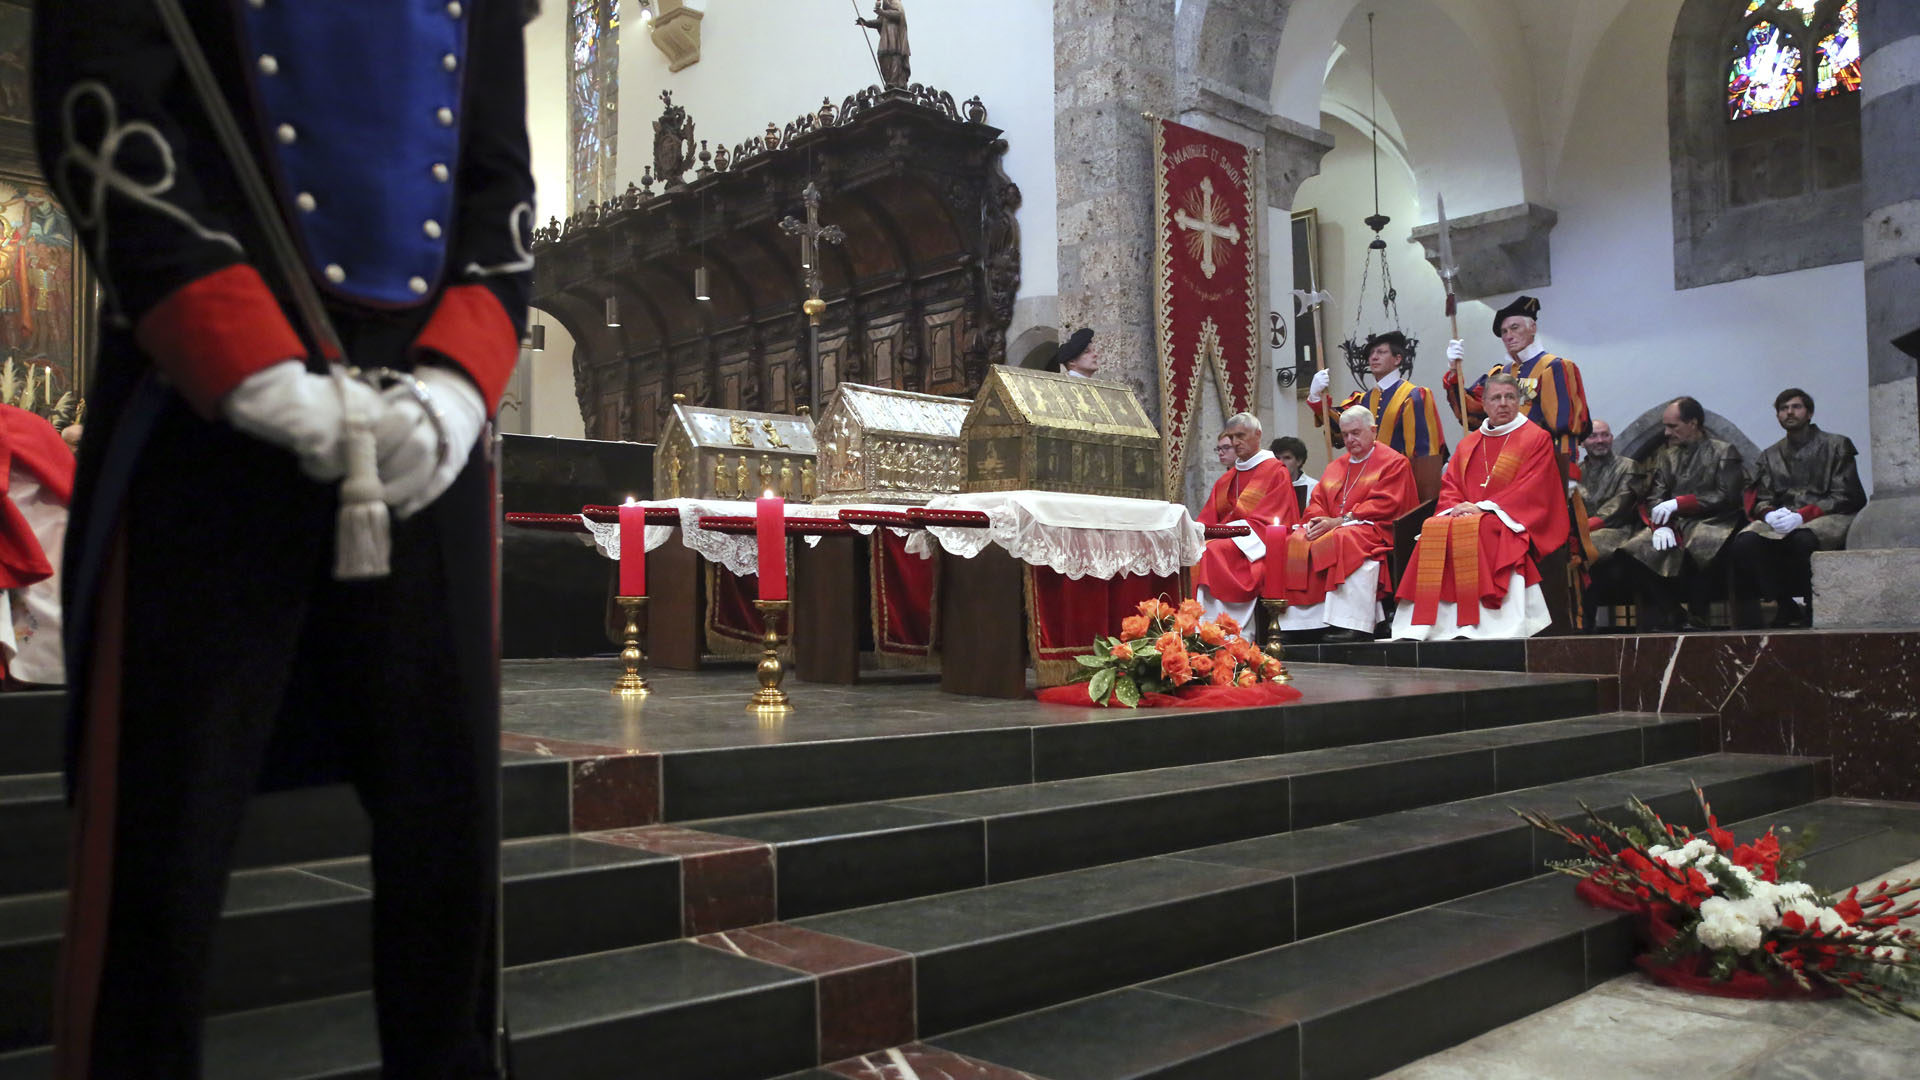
[818, 382, 973, 505]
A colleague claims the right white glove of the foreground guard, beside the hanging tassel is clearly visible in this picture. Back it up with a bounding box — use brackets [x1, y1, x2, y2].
[372, 363, 486, 519]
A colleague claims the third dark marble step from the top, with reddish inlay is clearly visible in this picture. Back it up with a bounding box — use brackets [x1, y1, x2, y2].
[0, 755, 1820, 1080]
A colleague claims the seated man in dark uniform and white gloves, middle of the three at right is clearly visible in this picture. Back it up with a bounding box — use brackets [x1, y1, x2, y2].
[1620, 398, 1745, 630]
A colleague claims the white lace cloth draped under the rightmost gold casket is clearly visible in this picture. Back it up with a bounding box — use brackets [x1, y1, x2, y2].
[906, 492, 1206, 580]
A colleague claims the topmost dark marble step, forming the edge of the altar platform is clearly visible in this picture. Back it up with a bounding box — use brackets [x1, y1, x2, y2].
[0, 675, 1599, 896]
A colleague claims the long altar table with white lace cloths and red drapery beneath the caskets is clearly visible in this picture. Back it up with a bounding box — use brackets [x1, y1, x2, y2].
[509, 484, 1204, 698]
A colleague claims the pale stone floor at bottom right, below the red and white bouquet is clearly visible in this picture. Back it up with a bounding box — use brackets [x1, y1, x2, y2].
[1388, 863, 1920, 1080]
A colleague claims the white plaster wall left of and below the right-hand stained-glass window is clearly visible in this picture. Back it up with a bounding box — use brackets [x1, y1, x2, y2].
[1520, 0, 1872, 484]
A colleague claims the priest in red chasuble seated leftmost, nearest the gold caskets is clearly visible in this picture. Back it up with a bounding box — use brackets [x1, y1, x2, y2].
[1194, 413, 1300, 626]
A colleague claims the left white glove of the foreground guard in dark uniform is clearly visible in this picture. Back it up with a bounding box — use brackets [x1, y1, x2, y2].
[221, 359, 380, 482]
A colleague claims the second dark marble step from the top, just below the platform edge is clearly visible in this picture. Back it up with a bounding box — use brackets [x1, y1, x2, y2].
[0, 713, 1713, 1049]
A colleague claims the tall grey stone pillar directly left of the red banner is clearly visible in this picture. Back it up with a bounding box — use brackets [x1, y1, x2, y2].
[1054, 0, 1173, 421]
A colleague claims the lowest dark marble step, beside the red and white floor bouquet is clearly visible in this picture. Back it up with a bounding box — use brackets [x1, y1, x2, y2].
[906, 799, 1920, 1080]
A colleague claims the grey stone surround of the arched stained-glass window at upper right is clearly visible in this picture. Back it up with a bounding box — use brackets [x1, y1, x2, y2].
[1667, 0, 1864, 288]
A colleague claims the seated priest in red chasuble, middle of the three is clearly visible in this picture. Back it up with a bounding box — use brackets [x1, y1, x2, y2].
[1275, 405, 1421, 636]
